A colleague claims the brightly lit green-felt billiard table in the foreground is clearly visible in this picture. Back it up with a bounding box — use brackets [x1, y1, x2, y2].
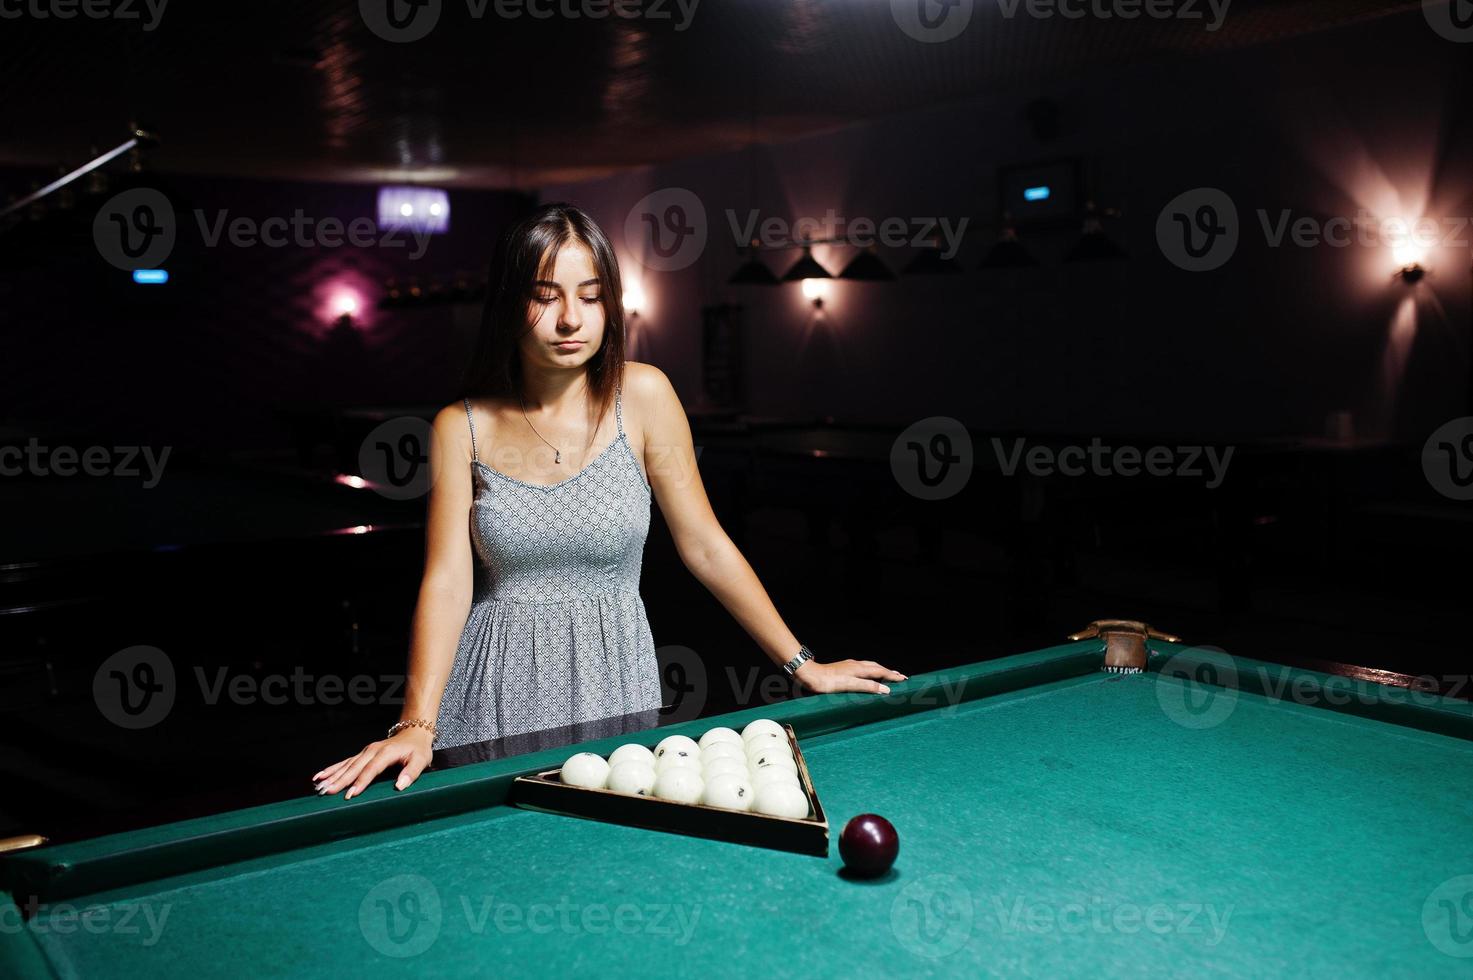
[0, 638, 1473, 979]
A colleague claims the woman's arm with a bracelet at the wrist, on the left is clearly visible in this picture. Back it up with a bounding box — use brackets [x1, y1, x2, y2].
[312, 405, 474, 800]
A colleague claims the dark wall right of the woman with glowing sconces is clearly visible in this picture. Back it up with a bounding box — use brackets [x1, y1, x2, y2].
[545, 10, 1473, 442]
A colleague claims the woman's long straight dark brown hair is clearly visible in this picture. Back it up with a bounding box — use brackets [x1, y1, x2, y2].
[465, 203, 625, 419]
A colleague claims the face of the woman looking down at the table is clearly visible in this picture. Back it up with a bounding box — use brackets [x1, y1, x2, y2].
[521, 242, 607, 368]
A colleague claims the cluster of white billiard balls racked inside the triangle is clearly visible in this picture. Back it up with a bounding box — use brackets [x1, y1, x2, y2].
[561, 718, 809, 818]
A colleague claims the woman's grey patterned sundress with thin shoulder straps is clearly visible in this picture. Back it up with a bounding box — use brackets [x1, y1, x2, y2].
[436, 392, 660, 747]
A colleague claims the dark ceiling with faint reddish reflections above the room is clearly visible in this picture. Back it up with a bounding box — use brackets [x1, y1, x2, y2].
[0, 0, 1418, 189]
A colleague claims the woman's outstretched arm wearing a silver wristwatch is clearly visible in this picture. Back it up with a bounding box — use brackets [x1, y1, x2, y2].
[629, 364, 906, 694]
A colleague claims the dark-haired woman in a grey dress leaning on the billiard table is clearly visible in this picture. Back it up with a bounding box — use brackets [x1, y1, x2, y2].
[312, 203, 904, 799]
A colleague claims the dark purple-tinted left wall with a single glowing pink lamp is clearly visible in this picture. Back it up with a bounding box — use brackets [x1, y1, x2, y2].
[0, 174, 527, 448]
